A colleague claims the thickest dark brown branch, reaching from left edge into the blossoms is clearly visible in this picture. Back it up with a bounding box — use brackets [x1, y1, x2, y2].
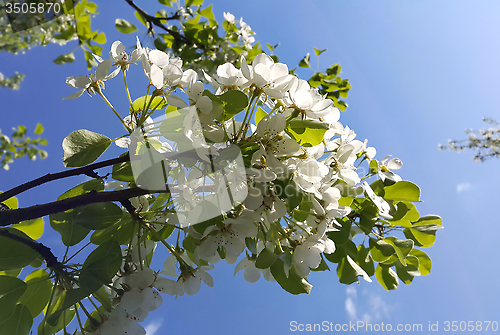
[0, 185, 170, 227]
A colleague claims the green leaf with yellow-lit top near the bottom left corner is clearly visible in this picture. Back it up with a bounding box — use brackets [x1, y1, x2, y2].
[19, 269, 52, 317]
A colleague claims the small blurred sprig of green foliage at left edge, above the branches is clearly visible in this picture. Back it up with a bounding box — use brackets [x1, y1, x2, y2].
[0, 123, 48, 170]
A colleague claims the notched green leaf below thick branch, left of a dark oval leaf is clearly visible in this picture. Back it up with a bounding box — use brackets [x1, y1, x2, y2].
[49, 213, 90, 247]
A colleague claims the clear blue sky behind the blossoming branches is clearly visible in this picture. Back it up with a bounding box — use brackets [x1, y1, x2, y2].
[0, 0, 500, 335]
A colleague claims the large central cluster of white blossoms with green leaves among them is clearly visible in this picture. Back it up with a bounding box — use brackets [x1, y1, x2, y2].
[60, 33, 432, 334]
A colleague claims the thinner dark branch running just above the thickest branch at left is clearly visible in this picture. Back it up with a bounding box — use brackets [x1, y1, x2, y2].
[0, 153, 130, 203]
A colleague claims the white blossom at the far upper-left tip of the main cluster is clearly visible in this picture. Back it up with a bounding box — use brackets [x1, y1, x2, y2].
[63, 59, 120, 99]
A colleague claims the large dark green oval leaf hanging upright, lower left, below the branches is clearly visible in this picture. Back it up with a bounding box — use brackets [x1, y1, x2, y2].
[80, 240, 122, 293]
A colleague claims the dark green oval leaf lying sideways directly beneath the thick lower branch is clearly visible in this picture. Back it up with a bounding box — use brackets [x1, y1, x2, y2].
[73, 202, 123, 230]
